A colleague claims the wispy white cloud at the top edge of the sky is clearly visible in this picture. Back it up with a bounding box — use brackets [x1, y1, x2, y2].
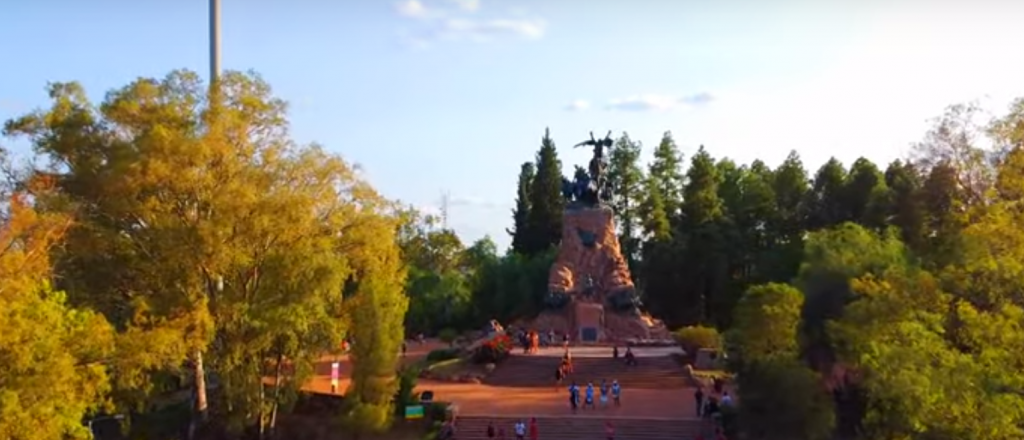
[395, 0, 547, 46]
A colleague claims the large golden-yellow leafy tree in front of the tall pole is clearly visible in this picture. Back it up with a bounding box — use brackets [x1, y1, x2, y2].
[5, 68, 404, 433]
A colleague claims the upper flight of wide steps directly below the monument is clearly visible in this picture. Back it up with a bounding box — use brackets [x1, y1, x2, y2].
[485, 355, 692, 390]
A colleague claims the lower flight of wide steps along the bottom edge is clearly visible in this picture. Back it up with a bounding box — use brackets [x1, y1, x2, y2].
[456, 416, 701, 440]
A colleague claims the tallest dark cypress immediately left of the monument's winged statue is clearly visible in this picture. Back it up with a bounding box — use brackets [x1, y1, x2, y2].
[524, 129, 565, 256]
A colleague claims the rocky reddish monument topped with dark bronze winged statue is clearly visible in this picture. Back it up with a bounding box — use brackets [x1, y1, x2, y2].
[534, 131, 671, 343]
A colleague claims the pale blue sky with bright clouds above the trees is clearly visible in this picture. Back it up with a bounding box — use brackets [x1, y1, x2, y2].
[0, 0, 1024, 246]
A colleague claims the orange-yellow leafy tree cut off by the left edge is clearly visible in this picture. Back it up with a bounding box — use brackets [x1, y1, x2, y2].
[0, 174, 114, 440]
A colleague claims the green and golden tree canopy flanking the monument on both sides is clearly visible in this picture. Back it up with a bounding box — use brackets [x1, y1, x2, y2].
[0, 66, 1024, 440]
